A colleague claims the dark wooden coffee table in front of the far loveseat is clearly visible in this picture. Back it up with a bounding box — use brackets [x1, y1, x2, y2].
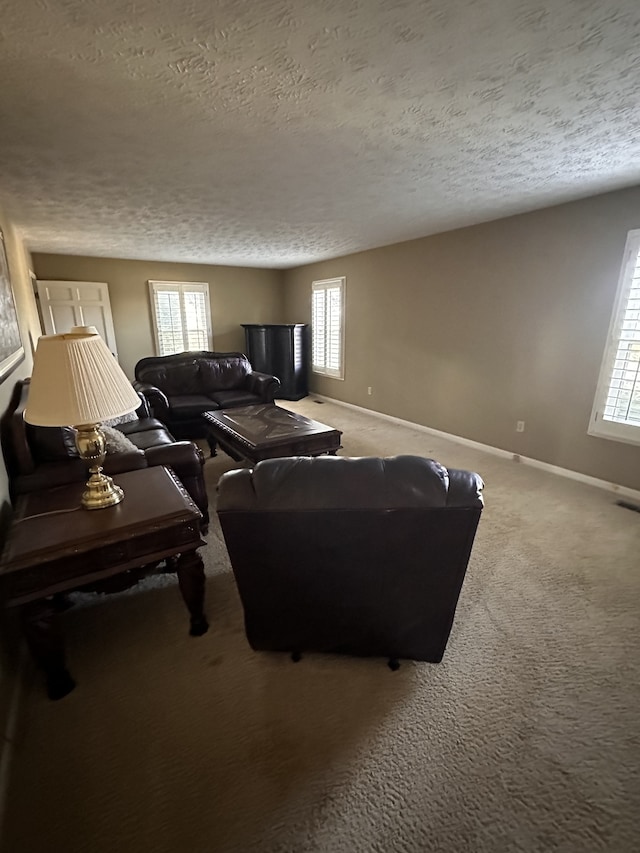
[202, 403, 342, 463]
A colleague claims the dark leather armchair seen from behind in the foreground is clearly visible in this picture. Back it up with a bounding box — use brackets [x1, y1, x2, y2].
[217, 456, 484, 668]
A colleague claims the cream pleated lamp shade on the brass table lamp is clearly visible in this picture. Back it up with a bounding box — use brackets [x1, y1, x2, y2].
[24, 326, 140, 426]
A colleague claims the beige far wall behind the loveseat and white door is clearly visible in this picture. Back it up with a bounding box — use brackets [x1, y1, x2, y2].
[33, 253, 284, 378]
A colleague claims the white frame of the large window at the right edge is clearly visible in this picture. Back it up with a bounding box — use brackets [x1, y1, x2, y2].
[587, 229, 640, 444]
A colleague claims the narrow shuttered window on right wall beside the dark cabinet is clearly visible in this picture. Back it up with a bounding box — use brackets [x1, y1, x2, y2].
[311, 277, 345, 379]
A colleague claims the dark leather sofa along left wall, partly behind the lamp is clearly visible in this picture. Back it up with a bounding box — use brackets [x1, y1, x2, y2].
[0, 379, 209, 532]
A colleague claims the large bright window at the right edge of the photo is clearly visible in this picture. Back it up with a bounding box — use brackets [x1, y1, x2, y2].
[589, 230, 640, 444]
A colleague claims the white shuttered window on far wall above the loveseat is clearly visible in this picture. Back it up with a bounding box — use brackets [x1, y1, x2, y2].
[149, 281, 213, 355]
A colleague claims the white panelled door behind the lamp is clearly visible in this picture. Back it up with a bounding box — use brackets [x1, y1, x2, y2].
[37, 281, 118, 358]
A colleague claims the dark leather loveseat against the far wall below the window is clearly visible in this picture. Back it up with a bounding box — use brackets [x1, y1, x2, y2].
[134, 351, 280, 446]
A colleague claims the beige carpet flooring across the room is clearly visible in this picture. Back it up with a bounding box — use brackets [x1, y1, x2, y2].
[2, 398, 640, 853]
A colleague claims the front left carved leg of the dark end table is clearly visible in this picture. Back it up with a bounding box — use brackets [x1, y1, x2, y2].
[22, 598, 76, 699]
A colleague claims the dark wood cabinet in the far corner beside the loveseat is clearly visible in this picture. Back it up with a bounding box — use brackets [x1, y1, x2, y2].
[242, 323, 309, 400]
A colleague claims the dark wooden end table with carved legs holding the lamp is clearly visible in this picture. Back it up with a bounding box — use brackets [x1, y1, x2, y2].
[0, 466, 208, 699]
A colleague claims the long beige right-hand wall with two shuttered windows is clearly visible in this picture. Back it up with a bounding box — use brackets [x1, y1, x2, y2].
[285, 188, 640, 489]
